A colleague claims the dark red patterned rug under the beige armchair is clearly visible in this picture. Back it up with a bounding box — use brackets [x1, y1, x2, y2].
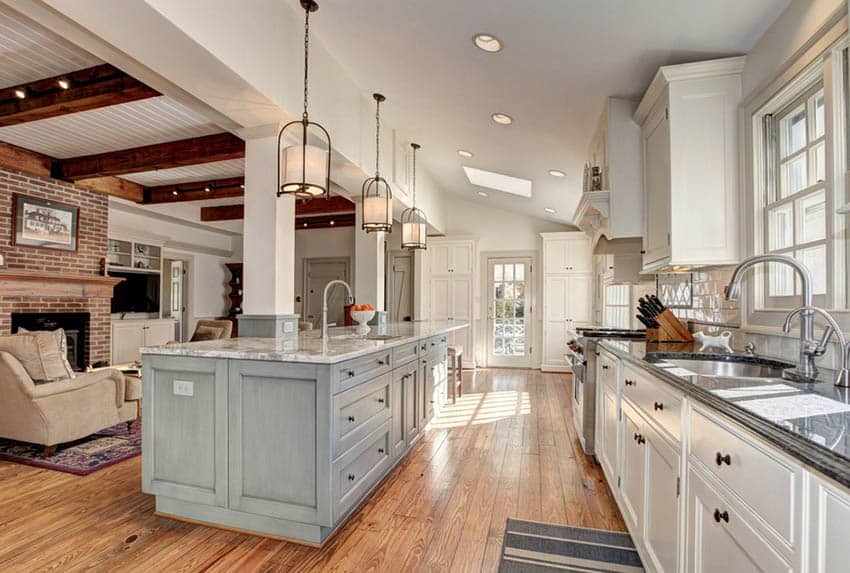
[0, 419, 142, 476]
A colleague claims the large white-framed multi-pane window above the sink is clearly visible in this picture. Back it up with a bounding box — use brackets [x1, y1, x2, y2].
[763, 83, 833, 308]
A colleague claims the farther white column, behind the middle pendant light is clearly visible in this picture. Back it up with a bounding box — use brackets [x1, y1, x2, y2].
[354, 201, 386, 311]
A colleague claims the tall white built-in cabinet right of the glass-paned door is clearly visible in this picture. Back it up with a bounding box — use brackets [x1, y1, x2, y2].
[541, 232, 593, 372]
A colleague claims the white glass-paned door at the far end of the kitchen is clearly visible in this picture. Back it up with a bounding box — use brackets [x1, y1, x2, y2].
[487, 257, 533, 368]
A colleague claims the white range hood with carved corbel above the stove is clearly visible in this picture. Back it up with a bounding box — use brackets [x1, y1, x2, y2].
[573, 98, 644, 239]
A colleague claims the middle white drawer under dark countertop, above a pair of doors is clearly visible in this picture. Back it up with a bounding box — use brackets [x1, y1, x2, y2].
[623, 366, 682, 442]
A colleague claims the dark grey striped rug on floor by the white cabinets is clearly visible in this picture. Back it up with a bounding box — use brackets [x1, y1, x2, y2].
[499, 518, 644, 573]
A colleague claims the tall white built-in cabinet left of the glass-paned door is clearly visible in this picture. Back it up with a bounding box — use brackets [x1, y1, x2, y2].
[425, 238, 477, 367]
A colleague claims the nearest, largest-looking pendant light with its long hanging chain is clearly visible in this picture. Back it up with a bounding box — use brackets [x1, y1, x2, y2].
[277, 0, 331, 199]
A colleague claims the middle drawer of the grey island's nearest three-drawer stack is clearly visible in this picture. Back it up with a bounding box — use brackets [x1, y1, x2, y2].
[333, 372, 392, 458]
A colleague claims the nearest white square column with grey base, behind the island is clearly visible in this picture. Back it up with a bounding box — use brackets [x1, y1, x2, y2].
[240, 130, 297, 336]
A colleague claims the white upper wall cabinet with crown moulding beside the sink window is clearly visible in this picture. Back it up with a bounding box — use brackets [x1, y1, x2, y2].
[634, 57, 744, 271]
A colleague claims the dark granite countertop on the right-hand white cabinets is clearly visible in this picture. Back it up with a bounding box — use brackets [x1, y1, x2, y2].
[599, 340, 850, 487]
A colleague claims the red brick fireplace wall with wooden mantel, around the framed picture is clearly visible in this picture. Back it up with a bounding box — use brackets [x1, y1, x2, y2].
[0, 165, 114, 363]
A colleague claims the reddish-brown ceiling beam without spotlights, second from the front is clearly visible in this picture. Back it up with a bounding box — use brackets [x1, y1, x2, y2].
[53, 133, 245, 181]
